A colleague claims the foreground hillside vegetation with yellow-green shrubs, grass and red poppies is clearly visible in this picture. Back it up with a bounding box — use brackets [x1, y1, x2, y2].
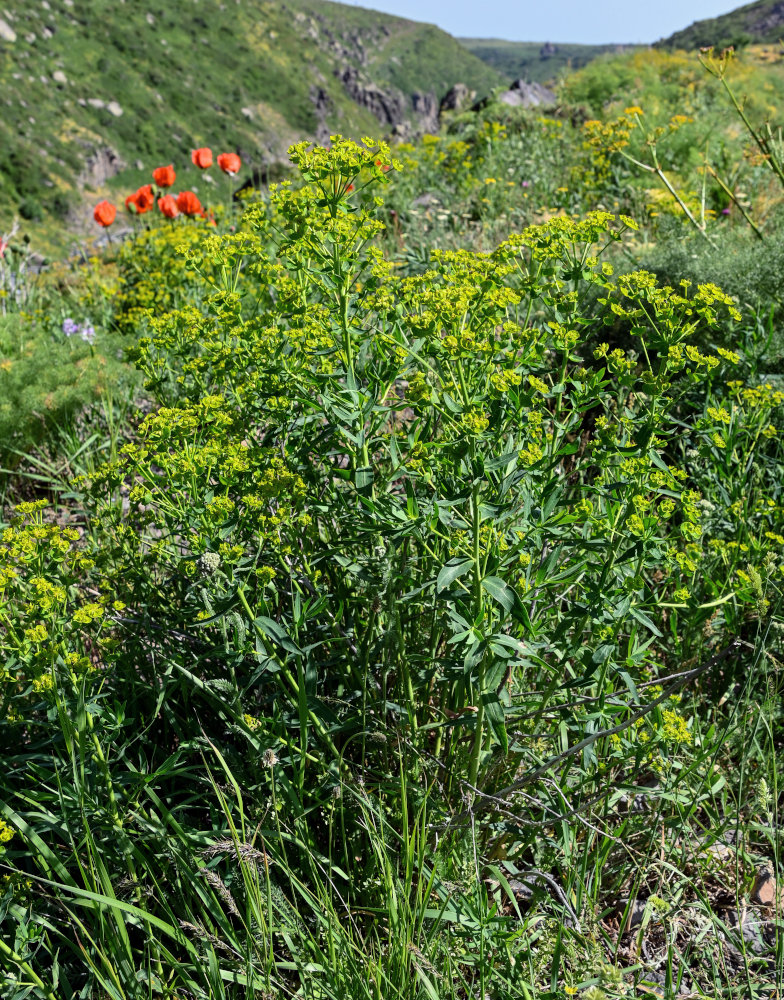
[0, 0, 784, 1000]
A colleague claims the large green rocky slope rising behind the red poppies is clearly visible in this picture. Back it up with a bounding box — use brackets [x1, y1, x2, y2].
[0, 0, 503, 229]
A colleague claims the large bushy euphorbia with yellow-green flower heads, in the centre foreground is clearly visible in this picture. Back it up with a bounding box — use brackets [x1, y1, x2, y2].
[87, 137, 776, 820]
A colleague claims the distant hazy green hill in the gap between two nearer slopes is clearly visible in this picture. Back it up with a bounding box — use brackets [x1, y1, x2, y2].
[460, 38, 635, 83]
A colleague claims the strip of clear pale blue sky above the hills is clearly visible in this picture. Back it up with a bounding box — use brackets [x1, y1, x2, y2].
[343, 0, 747, 43]
